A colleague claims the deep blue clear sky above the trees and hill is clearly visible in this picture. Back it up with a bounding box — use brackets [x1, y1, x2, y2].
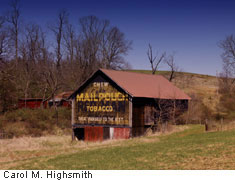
[0, 0, 235, 75]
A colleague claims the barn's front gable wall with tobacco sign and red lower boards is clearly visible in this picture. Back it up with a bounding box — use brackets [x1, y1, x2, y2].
[72, 72, 132, 141]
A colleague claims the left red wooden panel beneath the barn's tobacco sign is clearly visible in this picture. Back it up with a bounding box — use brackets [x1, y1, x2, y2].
[85, 126, 103, 141]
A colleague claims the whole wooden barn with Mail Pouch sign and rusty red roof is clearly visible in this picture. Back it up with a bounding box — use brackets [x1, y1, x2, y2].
[70, 69, 190, 141]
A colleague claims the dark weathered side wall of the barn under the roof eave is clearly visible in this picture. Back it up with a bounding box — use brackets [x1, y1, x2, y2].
[132, 98, 188, 137]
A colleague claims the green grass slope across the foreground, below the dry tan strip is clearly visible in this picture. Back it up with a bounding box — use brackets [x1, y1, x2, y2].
[3, 125, 235, 169]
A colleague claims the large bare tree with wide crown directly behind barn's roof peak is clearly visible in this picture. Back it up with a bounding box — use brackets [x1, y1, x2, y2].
[63, 16, 131, 87]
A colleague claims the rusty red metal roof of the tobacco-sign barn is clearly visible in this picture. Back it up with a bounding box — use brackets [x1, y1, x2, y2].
[100, 69, 191, 100]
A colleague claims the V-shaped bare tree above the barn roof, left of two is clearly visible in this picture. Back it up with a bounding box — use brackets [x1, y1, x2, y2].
[147, 44, 166, 74]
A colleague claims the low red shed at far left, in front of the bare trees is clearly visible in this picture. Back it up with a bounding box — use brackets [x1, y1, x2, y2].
[18, 98, 47, 109]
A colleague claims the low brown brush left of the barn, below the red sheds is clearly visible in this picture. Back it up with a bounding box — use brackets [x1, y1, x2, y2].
[0, 108, 71, 137]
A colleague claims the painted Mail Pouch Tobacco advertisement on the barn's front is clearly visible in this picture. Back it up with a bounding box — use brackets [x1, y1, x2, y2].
[76, 76, 129, 125]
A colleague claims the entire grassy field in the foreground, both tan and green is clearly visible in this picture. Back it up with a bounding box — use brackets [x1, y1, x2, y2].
[0, 125, 235, 169]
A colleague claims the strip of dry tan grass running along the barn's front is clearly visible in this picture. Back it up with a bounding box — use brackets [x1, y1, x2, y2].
[0, 126, 187, 169]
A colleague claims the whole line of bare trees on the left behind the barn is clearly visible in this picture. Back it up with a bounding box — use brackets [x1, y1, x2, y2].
[0, 0, 131, 112]
